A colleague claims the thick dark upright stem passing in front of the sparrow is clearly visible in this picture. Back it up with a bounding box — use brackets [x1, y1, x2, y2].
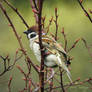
[38, 0, 44, 92]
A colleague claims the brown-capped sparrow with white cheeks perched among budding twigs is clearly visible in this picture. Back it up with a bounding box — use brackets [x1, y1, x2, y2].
[23, 26, 72, 82]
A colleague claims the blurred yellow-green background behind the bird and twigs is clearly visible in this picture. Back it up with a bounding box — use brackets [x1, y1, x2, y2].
[0, 0, 92, 92]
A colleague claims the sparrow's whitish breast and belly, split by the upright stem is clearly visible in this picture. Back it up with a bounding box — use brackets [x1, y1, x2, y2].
[30, 42, 57, 67]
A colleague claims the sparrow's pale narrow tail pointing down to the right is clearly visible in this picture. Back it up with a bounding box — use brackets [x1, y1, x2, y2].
[57, 53, 72, 82]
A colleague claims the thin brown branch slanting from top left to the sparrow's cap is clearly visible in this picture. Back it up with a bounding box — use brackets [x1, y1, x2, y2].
[3, 0, 29, 28]
